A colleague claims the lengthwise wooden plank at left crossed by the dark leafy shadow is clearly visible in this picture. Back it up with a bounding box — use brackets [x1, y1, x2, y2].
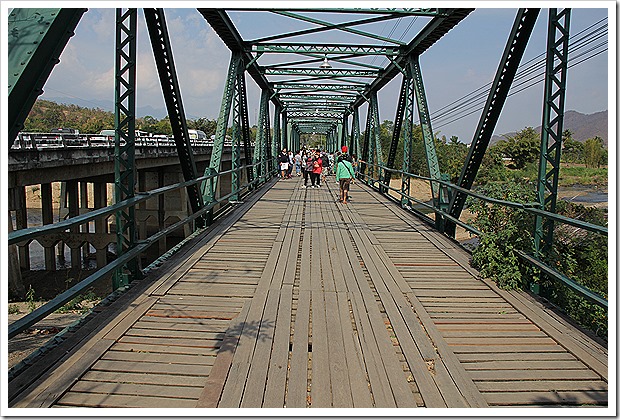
[196, 305, 249, 408]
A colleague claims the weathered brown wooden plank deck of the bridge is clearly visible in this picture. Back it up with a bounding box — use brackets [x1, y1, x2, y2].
[9, 176, 607, 407]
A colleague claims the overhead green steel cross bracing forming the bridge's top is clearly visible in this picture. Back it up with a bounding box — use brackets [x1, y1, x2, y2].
[199, 8, 473, 137]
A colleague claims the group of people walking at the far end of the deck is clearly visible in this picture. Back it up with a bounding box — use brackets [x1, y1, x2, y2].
[278, 146, 357, 204]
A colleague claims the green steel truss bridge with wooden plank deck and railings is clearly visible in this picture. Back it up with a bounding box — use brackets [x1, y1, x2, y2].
[7, 8, 608, 414]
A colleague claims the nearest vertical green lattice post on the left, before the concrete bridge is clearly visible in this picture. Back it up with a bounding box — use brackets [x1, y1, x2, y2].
[112, 9, 141, 290]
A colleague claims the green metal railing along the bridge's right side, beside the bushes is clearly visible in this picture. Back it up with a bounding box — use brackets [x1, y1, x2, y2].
[357, 160, 608, 311]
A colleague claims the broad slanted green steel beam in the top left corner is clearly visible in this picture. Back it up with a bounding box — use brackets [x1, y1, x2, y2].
[6, 8, 88, 149]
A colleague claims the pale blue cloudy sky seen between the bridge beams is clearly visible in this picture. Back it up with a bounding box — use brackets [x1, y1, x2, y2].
[14, 2, 615, 143]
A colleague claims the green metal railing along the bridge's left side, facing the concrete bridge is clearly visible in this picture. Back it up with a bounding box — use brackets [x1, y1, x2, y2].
[8, 159, 275, 338]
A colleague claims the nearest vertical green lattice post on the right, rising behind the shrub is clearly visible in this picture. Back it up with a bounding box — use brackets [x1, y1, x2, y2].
[534, 9, 571, 257]
